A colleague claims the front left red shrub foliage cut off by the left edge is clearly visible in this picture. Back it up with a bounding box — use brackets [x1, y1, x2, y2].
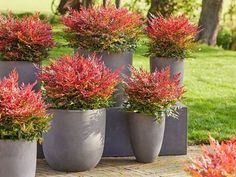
[0, 70, 50, 140]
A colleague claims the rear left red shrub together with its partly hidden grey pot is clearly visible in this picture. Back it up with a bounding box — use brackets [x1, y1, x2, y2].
[0, 14, 54, 90]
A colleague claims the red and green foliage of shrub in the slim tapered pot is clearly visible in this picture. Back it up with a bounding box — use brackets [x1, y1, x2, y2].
[124, 68, 185, 119]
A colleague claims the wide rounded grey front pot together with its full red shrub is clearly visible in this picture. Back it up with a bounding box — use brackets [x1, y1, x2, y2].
[39, 54, 119, 172]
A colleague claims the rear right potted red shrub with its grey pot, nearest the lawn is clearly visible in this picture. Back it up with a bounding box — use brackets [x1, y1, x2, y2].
[146, 15, 198, 84]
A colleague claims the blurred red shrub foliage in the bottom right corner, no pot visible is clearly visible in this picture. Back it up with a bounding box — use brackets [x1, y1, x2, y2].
[187, 137, 236, 177]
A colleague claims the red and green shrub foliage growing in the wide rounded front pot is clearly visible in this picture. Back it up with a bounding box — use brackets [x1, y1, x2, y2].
[39, 54, 119, 110]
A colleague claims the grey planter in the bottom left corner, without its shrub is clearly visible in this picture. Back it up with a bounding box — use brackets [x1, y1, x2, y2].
[0, 140, 36, 177]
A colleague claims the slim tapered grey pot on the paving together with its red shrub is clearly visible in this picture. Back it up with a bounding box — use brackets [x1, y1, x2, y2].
[124, 68, 184, 163]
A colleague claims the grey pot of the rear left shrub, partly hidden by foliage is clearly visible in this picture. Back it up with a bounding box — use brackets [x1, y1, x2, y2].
[0, 61, 40, 91]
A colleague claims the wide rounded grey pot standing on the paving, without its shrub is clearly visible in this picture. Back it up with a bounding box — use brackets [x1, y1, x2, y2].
[43, 109, 106, 172]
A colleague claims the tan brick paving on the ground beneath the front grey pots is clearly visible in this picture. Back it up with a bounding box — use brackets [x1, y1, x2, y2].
[36, 146, 200, 177]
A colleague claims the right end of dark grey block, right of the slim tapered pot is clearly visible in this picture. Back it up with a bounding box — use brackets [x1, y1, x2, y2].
[160, 103, 188, 156]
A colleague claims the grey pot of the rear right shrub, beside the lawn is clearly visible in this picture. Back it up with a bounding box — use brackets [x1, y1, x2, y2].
[150, 57, 184, 85]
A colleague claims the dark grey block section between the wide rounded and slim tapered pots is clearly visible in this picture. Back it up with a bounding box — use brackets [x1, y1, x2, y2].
[103, 107, 133, 157]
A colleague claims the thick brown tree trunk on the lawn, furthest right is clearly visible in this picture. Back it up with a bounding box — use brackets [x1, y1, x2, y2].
[197, 0, 223, 45]
